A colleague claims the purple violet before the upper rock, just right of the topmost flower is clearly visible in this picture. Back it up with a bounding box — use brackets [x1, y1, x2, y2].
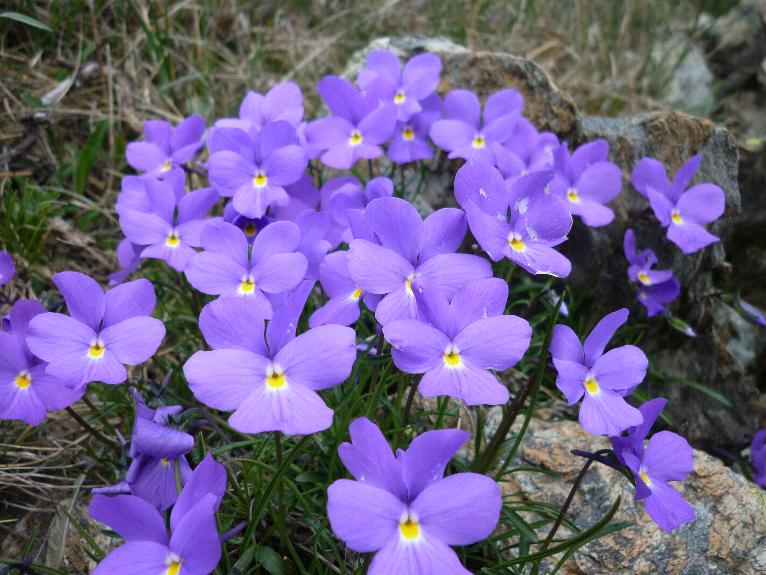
[430, 90, 524, 165]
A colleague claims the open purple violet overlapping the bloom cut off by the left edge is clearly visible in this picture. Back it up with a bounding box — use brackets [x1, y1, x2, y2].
[27, 272, 165, 389]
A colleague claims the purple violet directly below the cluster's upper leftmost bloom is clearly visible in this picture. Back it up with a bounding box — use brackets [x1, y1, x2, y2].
[120, 180, 220, 271]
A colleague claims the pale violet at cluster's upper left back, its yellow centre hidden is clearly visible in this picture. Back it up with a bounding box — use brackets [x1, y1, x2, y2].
[215, 82, 303, 133]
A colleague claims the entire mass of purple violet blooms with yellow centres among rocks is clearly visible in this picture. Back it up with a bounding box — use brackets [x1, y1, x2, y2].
[0, 45, 762, 575]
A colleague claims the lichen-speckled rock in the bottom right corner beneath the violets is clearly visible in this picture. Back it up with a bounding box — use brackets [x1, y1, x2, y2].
[502, 419, 766, 575]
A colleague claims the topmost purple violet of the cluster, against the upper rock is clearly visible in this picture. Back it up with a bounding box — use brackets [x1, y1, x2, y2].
[357, 50, 442, 122]
